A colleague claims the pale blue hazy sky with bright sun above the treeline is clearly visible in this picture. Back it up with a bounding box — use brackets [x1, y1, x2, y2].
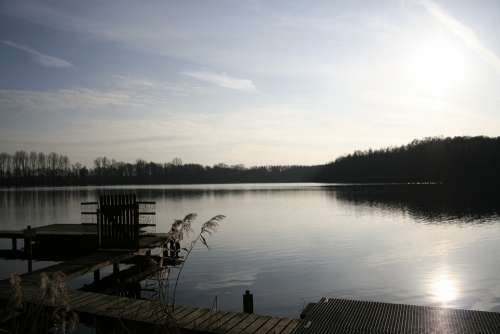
[0, 0, 500, 166]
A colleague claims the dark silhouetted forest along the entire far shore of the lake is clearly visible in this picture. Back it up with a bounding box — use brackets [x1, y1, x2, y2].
[0, 136, 500, 187]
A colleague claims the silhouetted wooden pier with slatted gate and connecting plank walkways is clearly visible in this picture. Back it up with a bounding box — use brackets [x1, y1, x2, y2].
[0, 194, 299, 334]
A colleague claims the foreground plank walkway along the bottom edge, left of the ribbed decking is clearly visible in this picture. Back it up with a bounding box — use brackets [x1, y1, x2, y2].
[0, 286, 299, 334]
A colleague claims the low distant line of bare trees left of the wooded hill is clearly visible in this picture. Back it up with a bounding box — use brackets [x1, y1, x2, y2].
[0, 151, 316, 187]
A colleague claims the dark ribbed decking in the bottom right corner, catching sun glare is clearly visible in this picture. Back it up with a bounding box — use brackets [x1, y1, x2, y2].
[294, 298, 500, 334]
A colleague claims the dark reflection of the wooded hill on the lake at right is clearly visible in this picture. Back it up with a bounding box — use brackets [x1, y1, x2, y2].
[325, 185, 500, 223]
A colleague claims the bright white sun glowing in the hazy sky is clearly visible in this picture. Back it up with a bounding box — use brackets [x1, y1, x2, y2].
[406, 37, 466, 95]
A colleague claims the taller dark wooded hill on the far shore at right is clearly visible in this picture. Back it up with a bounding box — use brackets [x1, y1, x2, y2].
[321, 136, 500, 185]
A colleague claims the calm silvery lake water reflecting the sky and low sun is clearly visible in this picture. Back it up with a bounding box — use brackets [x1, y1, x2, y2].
[0, 184, 500, 316]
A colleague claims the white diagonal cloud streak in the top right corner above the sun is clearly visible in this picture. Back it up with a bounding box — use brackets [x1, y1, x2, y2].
[422, 1, 500, 72]
